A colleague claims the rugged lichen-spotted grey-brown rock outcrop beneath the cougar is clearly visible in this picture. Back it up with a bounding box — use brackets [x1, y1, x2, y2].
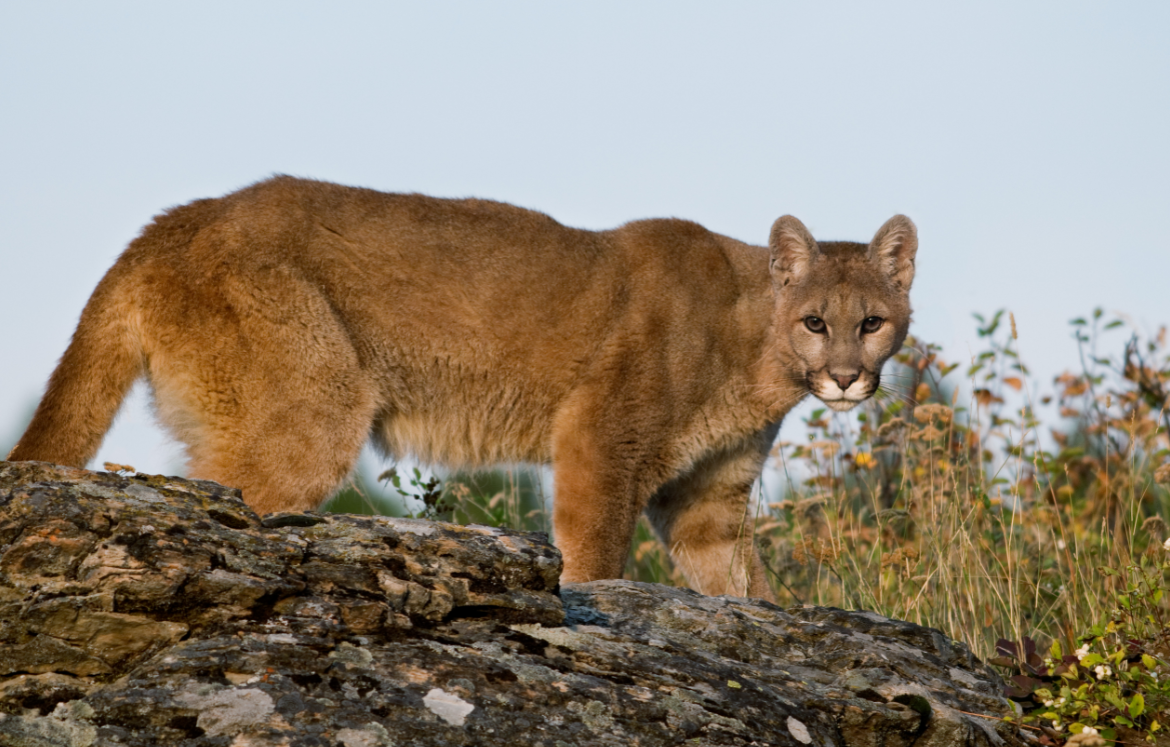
[0, 462, 1024, 747]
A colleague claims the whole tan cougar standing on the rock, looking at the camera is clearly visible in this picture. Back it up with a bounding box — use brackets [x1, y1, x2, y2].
[9, 177, 916, 598]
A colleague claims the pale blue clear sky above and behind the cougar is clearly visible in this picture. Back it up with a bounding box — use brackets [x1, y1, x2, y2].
[0, 1, 1170, 480]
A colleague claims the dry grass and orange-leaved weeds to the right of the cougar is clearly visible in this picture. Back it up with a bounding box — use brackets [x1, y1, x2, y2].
[758, 311, 1170, 657]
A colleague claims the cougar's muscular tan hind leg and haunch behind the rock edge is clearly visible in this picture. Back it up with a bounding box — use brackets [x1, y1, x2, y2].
[143, 273, 378, 514]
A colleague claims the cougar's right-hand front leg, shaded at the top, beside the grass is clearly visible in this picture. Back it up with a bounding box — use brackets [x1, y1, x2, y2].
[646, 433, 776, 602]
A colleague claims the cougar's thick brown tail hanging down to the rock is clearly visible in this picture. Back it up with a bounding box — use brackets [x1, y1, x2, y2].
[8, 275, 146, 467]
